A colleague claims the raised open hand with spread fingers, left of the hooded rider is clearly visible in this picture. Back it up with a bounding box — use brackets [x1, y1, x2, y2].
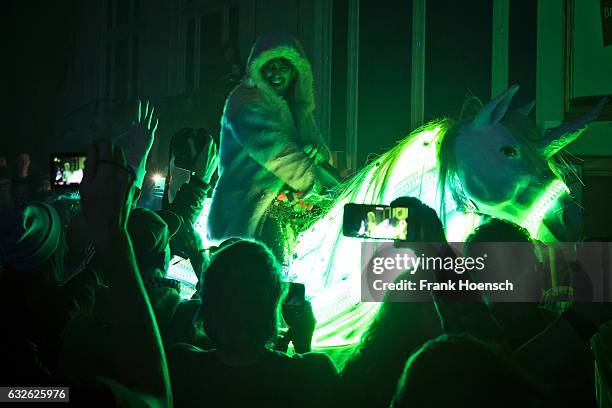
[128, 100, 159, 188]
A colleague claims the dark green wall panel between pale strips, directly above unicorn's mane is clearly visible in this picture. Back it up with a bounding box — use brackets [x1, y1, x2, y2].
[357, 0, 412, 165]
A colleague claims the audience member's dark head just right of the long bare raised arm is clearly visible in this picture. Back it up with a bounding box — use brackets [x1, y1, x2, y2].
[128, 208, 181, 279]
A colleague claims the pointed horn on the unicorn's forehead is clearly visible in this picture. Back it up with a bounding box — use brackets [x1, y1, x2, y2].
[539, 96, 609, 160]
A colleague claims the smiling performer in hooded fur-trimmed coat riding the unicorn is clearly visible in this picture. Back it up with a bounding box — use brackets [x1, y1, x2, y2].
[208, 34, 330, 262]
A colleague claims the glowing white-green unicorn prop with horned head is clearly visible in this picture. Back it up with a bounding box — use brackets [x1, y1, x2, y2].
[290, 86, 606, 347]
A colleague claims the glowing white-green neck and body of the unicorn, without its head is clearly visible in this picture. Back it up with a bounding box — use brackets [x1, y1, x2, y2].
[288, 119, 486, 346]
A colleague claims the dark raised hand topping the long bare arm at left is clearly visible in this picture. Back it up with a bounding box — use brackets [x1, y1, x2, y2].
[80, 140, 134, 248]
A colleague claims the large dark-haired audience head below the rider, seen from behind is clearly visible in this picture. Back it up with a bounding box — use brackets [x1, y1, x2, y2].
[196, 240, 284, 352]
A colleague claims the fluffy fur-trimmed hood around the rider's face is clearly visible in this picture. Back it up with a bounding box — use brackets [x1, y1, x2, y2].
[243, 33, 315, 112]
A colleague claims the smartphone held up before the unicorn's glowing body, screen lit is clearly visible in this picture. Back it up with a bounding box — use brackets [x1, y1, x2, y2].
[342, 203, 408, 241]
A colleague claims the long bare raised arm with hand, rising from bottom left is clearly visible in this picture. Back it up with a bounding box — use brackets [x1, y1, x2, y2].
[81, 141, 172, 406]
